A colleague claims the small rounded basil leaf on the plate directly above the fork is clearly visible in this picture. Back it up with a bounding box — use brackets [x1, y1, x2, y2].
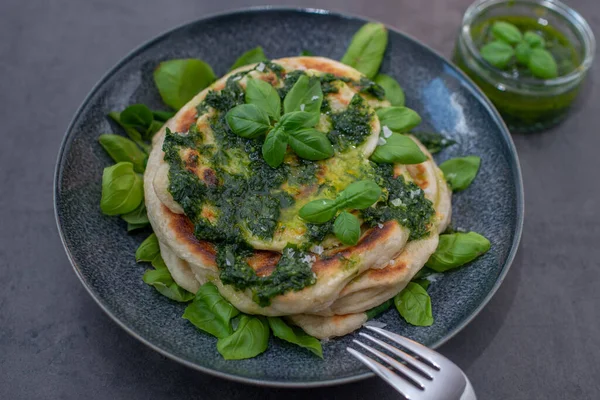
[394, 282, 433, 326]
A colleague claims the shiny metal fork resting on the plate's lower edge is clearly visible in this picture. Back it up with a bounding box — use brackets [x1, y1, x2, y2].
[346, 325, 477, 400]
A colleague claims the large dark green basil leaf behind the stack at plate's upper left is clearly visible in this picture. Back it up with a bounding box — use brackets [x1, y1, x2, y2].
[154, 58, 216, 110]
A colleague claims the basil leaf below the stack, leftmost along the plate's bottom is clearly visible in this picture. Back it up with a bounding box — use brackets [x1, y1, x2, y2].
[183, 282, 240, 338]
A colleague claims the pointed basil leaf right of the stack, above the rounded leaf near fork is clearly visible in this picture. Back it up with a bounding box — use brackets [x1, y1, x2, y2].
[425, 232, 491, 272]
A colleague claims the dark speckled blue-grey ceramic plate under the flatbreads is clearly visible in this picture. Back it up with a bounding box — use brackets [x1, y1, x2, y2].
[55, 9, 523, 387]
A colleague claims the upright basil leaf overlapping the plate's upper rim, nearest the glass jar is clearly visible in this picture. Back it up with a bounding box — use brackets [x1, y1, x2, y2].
[341, 22, 388, 79]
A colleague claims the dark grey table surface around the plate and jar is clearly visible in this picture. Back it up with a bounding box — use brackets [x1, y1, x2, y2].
[0, 0, 600, 400]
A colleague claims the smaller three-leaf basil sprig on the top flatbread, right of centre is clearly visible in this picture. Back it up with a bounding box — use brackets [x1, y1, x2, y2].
[299, 180, 381, 246]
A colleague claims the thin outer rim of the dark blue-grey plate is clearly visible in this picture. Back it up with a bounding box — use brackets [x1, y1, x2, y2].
[52, 6, 525, 388]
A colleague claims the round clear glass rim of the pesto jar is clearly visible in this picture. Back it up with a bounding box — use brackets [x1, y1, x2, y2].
[460, 0, 596, 87]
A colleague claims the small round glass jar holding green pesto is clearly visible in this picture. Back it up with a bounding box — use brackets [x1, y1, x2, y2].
[453, 0, 596, 132]
